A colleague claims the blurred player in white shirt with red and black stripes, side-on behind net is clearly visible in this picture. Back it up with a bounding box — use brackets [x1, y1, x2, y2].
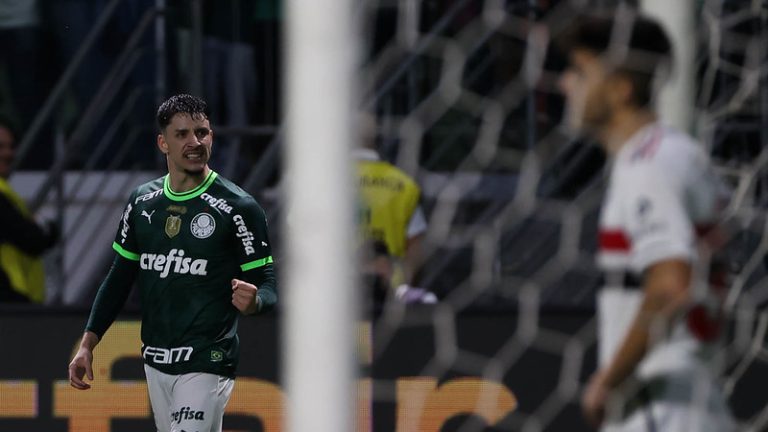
[559, 10, 734, 432]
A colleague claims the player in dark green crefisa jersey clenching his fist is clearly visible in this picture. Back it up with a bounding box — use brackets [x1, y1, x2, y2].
[69, 95, 277, 432]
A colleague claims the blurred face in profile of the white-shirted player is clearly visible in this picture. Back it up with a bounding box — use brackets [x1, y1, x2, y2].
[560, 49, 611, 132]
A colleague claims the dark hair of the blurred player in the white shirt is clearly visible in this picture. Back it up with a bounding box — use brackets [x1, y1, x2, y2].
[555, 11, 673, 107]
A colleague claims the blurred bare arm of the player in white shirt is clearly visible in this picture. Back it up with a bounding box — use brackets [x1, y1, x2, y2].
[582, 259, 691, 425]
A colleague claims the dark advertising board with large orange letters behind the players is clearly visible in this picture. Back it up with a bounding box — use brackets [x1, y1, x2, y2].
[0, 310, 768, 432]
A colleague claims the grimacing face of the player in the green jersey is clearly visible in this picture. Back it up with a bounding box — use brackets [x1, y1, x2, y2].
[157, 114, 213, 175]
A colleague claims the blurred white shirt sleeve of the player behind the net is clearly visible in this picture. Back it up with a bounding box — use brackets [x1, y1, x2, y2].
[620, 164, 695, 270]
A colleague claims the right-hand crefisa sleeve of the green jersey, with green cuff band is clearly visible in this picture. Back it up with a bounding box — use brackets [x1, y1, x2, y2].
[232, 200, 277, 312]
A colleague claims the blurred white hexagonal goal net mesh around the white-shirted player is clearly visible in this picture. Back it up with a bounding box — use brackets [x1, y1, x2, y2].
[356, 0, 768, 431]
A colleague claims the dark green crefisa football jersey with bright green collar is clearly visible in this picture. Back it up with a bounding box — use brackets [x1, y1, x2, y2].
[108, 171, 274, 376]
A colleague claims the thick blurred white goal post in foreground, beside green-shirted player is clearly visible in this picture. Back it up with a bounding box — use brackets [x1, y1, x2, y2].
[281, 0, 358, 432]
